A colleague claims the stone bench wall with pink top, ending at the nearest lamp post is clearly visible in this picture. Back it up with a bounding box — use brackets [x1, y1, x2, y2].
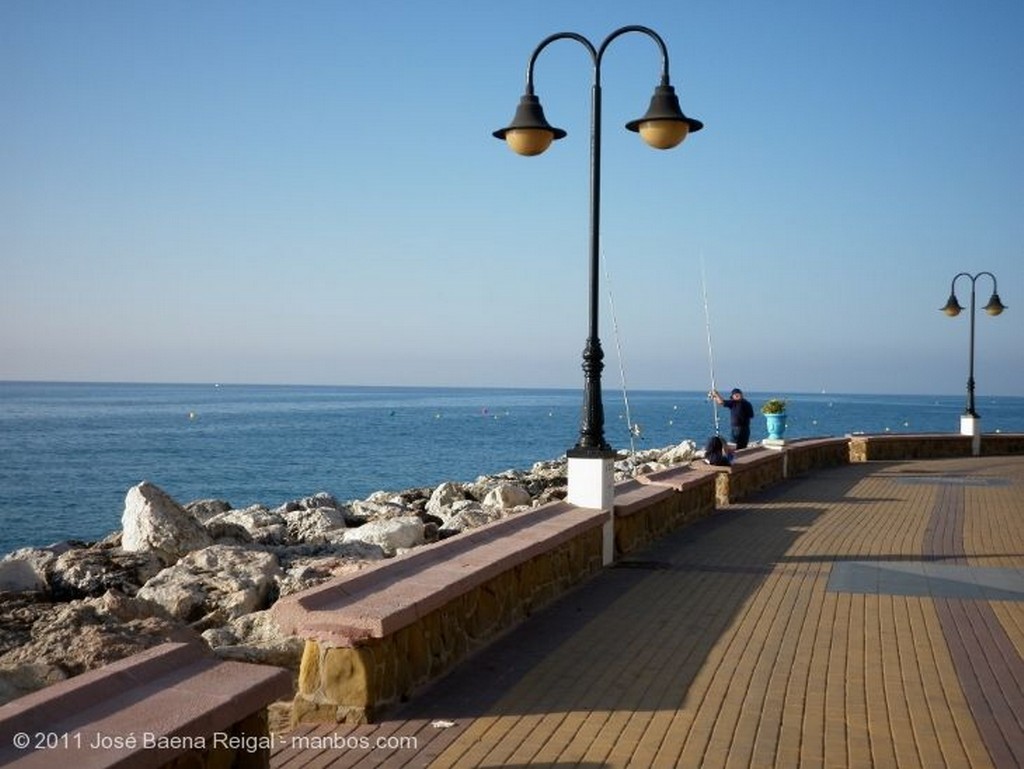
[273, 502, 609, 723]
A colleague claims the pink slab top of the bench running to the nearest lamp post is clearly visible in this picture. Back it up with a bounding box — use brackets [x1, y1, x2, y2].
[271, 502, 608, 646]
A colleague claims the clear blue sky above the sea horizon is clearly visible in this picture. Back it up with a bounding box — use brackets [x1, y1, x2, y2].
[0, 0, 1024, 395]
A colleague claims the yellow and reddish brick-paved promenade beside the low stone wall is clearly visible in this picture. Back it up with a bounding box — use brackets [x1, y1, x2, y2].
[272, 457, 1024, 769]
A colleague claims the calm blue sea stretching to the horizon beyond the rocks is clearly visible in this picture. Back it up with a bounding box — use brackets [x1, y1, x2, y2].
[0, 382, 1024, 554]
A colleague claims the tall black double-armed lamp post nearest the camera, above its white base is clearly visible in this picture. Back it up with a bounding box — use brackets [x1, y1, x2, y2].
[494, 26, 703, 459]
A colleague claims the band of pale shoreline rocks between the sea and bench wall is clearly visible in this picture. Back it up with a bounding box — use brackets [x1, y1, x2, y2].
[0, 440, 696, 703]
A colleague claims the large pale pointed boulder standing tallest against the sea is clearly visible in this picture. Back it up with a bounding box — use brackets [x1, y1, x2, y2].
[121, 481, 213, 563]
